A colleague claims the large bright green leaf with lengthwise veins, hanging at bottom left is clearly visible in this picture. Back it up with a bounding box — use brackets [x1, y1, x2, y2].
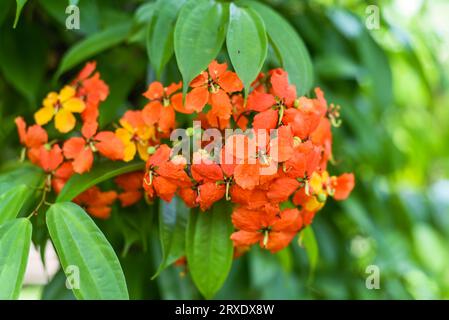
[46, 202, 129, 300]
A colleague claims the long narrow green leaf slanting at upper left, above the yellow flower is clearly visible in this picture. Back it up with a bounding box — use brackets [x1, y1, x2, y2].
[55, 22, 131, 79]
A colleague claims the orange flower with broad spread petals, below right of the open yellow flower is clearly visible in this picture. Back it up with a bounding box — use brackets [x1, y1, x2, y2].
[63, 126, 125, 174]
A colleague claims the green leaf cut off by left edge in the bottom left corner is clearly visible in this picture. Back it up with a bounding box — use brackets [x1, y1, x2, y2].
[0, 218, 32, 300]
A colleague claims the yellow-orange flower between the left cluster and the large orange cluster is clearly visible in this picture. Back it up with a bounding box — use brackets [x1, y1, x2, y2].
[115, 119, 155, 162]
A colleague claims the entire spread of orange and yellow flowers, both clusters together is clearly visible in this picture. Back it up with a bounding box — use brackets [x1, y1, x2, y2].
[16, 61, 354, 255]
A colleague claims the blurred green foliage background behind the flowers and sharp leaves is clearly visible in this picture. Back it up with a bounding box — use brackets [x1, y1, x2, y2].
[0, 0, 449, 299]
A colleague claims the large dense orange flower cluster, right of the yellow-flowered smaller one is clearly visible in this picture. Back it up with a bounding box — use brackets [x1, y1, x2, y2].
[143, 61, 354, 252]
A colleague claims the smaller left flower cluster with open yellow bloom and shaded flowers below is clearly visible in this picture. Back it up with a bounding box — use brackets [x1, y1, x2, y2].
[15, 62, 147, 218]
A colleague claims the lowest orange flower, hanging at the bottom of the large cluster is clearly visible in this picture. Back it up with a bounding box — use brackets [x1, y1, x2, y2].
[231, 207, 302, 252]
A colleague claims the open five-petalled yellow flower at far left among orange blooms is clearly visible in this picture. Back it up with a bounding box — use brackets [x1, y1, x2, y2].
[34, 86, 86, 133]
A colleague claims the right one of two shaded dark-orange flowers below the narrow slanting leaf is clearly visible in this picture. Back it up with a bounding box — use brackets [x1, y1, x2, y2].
[115, 171, 144, 207]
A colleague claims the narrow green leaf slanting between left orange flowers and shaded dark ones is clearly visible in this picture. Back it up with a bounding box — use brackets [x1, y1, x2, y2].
[56, 161, 145, 202]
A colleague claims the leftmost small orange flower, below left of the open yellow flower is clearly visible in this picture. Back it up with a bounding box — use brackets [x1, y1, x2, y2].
[15, 117, 48, 164]
